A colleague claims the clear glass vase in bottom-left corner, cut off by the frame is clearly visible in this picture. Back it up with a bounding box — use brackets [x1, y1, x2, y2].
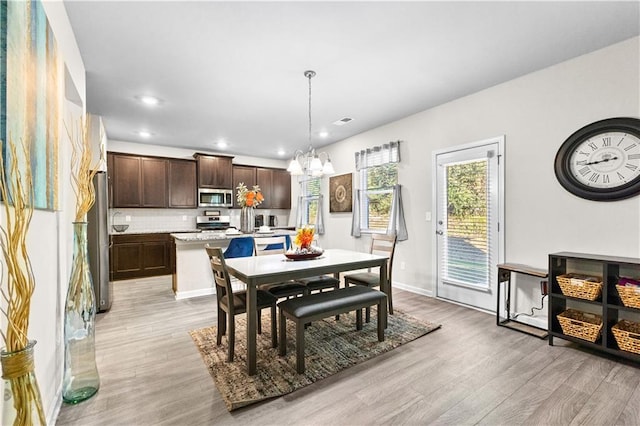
[0, 340, 47, 426]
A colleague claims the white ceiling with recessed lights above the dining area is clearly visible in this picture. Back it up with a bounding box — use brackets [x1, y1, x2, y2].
[65, 0, 640, 158]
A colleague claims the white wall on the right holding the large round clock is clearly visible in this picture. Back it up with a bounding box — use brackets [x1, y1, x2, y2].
[321, 37, 640, 322]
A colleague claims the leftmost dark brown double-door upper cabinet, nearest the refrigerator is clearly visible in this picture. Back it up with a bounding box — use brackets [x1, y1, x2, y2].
[107, 153, 168, 208]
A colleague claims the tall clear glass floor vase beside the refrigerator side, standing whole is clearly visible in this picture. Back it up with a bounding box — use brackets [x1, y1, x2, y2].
[62, 222, 100, 404]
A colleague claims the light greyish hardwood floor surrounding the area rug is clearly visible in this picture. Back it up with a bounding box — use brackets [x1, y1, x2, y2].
[57, 277, 640, 425]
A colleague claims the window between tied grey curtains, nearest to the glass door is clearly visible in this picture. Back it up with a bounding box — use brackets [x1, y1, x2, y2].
[360, 163, 398, 232]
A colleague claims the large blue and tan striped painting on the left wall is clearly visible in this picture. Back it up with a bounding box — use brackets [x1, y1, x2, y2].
[0, 1, 63, 210]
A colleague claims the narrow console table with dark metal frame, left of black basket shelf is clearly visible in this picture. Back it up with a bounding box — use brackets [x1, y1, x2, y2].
[496, 263, 549, 339]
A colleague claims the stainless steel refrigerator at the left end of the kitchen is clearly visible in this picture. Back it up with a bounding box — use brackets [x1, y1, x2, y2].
[87, 172, 112, 312]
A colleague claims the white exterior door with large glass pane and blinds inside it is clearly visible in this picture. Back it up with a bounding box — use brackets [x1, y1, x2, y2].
[433, 137, 504, 312]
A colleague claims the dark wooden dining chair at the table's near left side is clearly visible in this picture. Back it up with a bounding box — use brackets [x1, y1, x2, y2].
[205, 245, 278, 362]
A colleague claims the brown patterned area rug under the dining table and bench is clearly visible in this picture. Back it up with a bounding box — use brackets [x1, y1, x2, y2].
[189, 310, 440, 411]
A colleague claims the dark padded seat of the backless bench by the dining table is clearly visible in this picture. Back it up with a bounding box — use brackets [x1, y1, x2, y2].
[278, 286, 386, 318]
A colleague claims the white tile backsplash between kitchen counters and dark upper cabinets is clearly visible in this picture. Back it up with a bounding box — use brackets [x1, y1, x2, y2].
[109, 209, 289, 234]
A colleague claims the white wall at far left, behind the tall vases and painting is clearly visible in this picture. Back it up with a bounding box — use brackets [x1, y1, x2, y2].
[13, 2, 86, 424]
